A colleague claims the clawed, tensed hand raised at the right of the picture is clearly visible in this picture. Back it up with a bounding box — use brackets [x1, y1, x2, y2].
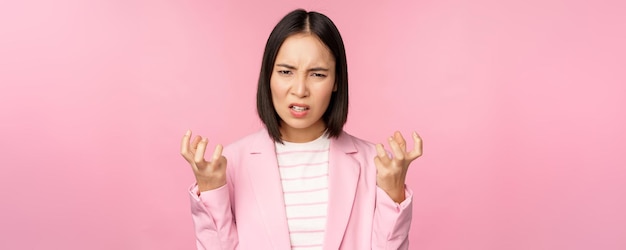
[374, 131, 422, 203]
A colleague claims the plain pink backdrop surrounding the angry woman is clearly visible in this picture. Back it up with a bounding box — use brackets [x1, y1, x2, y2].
[0, 0, 626, 250]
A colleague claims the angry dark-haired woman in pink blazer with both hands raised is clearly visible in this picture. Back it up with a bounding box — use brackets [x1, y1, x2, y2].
[181, 10, 422, 249]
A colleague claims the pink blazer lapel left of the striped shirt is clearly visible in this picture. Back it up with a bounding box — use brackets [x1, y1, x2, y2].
[245, 129, 291, 249]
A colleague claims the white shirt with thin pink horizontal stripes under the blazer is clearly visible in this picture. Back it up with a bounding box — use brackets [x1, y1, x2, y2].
[275, 134, 330, 250]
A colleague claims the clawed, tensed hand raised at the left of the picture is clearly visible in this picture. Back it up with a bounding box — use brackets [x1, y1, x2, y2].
[180, 130, 226, 192]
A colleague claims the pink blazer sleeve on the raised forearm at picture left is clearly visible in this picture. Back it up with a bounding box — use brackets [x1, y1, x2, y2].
[189, 184, 239, 250]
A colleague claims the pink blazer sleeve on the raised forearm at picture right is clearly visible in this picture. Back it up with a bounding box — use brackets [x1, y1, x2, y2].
[372, 186, 413, 250]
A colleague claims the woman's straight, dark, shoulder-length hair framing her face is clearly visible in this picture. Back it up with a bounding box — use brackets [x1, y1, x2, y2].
[256, 9, 348, 142]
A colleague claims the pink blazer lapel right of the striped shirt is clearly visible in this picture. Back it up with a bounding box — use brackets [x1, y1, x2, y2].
[324, 133, 361, 249]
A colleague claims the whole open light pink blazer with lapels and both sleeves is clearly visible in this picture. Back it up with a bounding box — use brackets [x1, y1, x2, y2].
[189, 129, 412, 250]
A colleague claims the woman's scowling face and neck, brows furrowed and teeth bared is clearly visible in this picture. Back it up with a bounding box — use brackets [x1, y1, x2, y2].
[270, 33, 336, 142]
